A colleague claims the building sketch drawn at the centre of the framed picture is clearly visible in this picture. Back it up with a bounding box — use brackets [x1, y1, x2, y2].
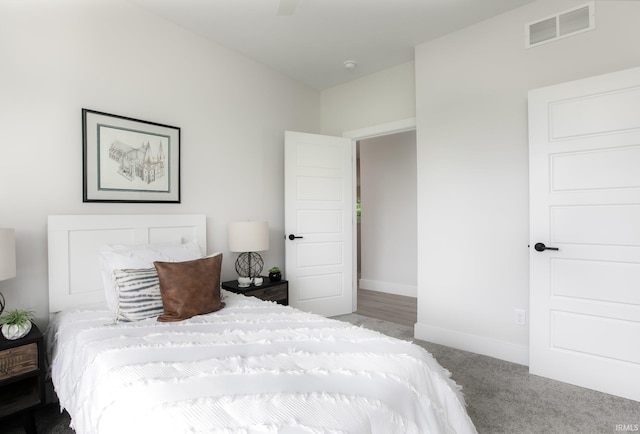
[109, 140, 166, 184]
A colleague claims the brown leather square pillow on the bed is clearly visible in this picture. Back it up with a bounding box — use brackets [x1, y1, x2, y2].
[153, 253, 224, 321]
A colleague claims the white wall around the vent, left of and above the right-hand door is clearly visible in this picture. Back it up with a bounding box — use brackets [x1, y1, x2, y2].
[415, 0, 640, 364]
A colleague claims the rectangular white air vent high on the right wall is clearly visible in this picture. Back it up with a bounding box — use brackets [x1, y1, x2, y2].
[525, 1, 596, 48]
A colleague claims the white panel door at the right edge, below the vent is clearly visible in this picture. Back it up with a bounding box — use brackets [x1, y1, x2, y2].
[529, 64, 640, 400]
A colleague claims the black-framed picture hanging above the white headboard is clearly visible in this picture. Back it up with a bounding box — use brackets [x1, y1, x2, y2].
[82, 109, 180, 203]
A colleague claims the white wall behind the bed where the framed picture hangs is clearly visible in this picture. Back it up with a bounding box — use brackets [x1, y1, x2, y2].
[0, 0, 320, 325]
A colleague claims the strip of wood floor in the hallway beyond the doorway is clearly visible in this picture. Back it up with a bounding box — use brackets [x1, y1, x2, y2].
[355, 288, 418, 327]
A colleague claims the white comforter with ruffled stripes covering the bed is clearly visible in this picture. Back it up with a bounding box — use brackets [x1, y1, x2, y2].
[49, 291, 475, 434]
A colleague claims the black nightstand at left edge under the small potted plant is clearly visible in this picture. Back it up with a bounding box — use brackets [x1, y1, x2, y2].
[0, 324, 45, 434]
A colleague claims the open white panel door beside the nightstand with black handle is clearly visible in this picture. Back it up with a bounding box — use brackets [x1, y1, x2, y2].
[284, 131, 355, 316]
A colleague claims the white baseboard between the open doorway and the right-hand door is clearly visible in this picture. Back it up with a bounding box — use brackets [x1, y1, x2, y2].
[414, 323, 529, 366]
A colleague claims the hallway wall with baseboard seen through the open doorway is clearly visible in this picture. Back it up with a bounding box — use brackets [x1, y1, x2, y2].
[360, 131, 418, 297]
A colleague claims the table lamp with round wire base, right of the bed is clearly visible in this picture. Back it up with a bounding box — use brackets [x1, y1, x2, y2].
[229, 221, 269, 278]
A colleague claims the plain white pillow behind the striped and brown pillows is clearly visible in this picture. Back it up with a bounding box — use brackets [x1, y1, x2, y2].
[98, 241, 202, 311]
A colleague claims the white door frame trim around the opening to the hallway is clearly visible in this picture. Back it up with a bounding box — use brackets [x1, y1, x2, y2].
[342, 117, 417, 312]
